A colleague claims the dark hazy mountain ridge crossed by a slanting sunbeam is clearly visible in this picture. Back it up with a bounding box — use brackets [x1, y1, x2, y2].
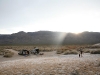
[0, 31, 100, 45]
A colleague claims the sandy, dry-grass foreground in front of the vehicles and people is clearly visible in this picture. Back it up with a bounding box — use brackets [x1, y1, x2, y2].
[0, 50, 100, 75]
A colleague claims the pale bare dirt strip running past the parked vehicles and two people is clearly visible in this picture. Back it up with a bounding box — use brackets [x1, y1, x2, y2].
[0, 49, 100, 62]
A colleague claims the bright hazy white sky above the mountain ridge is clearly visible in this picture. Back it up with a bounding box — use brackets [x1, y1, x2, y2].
[0, 0, 100, 34]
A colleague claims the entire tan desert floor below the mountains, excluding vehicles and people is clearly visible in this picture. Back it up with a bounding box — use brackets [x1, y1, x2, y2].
[0, 45, 100, 75]
